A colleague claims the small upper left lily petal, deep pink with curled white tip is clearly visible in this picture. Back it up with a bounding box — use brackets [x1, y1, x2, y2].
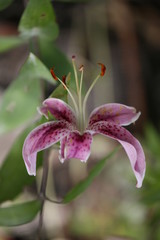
[39, 98, 76, 125]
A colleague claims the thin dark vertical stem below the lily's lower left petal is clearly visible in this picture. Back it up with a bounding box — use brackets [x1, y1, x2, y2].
[38, 151, 49, 240]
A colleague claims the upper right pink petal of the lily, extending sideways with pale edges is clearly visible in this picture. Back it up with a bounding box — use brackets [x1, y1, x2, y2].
[89, 103, 140, 126]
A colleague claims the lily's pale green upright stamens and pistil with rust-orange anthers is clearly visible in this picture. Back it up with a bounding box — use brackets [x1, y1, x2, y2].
[50, 56, 106, 134]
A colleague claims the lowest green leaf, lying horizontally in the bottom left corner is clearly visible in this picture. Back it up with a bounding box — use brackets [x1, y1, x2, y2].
[0, 200, 41, 227]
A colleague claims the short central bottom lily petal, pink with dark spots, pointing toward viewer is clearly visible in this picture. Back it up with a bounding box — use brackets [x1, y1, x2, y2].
[60, 131, 92, 162]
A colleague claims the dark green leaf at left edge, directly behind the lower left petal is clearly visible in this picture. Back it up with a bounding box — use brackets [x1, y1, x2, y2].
[0, 126, 43, 203]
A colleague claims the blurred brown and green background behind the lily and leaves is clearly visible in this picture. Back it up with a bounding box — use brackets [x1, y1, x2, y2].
[0, 0, 160, 240]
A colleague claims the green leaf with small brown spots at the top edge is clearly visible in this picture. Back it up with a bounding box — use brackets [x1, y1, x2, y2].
[19, 0, 58, 40]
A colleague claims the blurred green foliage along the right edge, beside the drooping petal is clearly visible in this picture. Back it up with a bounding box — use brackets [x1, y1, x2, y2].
[141, 123, 160, 240]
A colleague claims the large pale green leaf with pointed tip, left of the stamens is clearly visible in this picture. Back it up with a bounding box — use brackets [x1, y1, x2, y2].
[0, 53, 55, 134]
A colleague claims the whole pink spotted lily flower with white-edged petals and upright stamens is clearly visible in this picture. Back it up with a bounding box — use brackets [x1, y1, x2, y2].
[23, 57, 145, 188]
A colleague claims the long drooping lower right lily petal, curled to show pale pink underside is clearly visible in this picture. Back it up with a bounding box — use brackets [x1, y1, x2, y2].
[90, 121, 146, 188]
